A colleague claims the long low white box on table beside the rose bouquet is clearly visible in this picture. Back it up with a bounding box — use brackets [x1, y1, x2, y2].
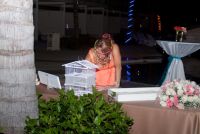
[108, 87, 160, 102]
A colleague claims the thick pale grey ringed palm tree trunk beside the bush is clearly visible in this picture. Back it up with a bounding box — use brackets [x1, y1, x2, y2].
[0, 0, 38, 134]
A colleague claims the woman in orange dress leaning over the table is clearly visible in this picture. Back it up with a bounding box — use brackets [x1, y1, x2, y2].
[86, 33, 121, 90]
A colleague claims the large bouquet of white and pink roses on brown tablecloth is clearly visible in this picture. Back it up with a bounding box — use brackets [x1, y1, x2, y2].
[159, 80, 200, 109]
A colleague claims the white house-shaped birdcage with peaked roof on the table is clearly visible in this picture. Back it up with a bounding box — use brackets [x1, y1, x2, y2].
[63, 60, 98, 95]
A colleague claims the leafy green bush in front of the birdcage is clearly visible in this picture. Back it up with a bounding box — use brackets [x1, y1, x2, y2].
[25, 89, 133, 134]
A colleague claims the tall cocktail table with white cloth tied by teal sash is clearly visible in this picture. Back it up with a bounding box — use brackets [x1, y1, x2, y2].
[157, 40, 200, 85]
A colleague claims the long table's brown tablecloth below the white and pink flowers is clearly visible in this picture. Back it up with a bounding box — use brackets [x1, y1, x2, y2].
[122, 101, 200, 134]
